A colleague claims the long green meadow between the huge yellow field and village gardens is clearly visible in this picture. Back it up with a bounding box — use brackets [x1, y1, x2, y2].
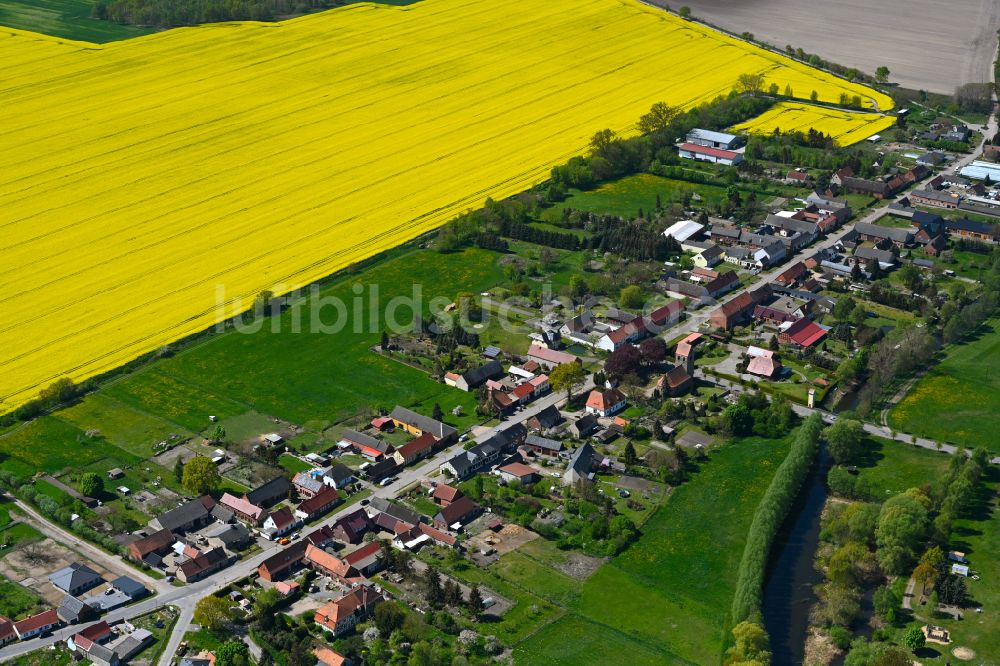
[134, 245, 501, 430]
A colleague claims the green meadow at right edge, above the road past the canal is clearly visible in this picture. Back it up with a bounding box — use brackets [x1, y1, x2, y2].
[889, 319, 1000, 452]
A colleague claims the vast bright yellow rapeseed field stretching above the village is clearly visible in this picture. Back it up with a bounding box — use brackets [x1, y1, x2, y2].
[0, 0, 891, 408]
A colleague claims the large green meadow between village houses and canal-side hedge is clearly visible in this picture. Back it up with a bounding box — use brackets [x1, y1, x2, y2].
[520, 438, 789, 664]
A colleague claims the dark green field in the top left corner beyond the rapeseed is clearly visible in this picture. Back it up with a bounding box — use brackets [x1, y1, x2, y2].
[0, 0, 153, 44]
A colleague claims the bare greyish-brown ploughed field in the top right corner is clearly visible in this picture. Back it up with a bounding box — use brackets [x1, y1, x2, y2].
[646, 0, 1000, 94]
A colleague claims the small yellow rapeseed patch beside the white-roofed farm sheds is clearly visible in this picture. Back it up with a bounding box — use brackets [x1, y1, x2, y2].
[730, 102, 896, 146]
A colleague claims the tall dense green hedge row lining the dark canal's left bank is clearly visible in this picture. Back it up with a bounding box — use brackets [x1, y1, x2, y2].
[731, 414, 823, 624]
